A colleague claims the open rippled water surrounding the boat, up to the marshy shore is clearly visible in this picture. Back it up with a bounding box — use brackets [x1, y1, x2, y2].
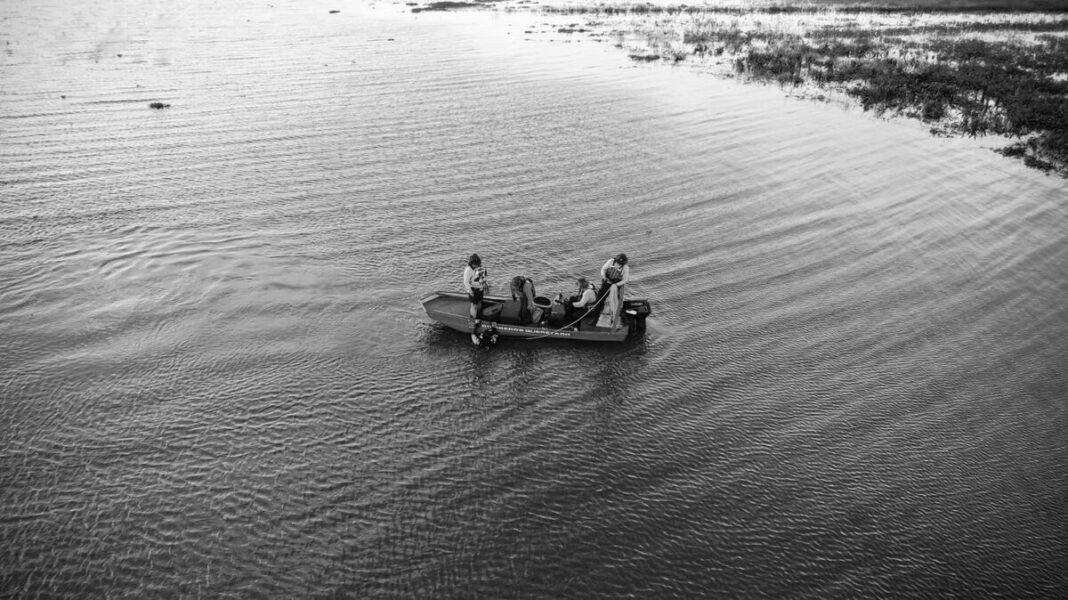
[0, 0, 1068, 598]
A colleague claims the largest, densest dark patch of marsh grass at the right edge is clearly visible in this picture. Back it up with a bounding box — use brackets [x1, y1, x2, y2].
[738, 23, 1068, 172]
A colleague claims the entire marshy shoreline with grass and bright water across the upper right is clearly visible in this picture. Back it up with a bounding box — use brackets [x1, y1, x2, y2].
[408, 0, 1068, 177]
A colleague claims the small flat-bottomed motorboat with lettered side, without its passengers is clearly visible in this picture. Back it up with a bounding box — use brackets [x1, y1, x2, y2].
[420, 291, 651, 345]
